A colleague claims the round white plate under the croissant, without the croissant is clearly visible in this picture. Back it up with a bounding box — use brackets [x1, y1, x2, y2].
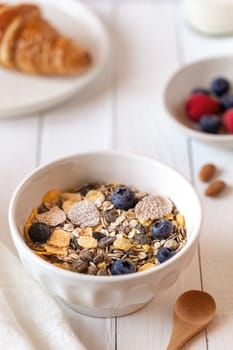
[0, 0, 108, 118]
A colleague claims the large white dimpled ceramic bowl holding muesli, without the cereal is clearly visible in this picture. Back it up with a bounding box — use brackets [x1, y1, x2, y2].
[9, 151, 202, 317]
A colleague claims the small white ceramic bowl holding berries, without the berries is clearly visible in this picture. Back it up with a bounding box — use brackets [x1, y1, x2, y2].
[164, 57, 233, 148]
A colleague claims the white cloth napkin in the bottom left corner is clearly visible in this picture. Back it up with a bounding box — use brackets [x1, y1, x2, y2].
[0, 242, 85, 350]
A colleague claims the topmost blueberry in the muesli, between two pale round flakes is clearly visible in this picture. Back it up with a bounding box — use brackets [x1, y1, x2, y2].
[111, 186, 136, 210]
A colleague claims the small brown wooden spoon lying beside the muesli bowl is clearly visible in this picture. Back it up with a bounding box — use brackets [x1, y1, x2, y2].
[167, 290, 216, 350]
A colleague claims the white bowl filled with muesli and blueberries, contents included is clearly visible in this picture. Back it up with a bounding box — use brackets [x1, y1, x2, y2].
[9, 151, 202, 317]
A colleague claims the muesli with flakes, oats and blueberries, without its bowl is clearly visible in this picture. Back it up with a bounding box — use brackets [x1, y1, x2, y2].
[24, 183, 187, 276]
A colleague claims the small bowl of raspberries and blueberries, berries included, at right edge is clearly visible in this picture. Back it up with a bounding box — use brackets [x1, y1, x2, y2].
[164, 57, 233, 148]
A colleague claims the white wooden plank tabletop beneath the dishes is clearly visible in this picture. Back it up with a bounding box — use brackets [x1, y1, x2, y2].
[0, 0, 233, 350]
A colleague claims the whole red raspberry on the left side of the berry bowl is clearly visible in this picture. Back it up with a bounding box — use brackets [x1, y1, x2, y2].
[186, 94, 220, 122]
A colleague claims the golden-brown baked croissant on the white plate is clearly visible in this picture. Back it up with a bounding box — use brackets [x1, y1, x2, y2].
[0, 4, 91, 75]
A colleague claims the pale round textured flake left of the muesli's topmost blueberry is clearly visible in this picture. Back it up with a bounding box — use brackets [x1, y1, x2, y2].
[68, 200, 100, 227]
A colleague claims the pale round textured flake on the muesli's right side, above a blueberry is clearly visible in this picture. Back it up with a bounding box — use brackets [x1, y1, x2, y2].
[135, 195, 173, 221]
